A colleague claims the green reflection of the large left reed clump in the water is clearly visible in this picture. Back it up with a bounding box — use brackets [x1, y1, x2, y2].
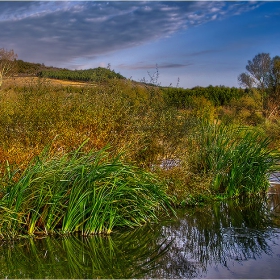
[0, 227, 170, 279]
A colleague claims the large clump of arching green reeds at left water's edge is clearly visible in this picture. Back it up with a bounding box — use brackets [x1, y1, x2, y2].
[0, 144, 172, 238]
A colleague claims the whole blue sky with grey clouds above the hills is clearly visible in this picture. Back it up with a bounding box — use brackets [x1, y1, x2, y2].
[0, 0, 280, 88]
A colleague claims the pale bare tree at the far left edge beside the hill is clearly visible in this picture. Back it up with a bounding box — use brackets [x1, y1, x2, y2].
[0, 48, 17, 87]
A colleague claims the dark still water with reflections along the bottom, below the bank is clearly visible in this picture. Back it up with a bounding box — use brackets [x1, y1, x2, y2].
[0, 184, 280, 279]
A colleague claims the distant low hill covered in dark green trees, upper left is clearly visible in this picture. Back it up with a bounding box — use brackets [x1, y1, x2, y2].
[16, 60, 125, 82]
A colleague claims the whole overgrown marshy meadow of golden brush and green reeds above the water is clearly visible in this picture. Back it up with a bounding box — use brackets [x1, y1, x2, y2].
[0, 72, 280, 238]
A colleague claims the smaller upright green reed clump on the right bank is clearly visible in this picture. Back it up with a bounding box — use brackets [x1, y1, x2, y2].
[189, 121, 279, 196]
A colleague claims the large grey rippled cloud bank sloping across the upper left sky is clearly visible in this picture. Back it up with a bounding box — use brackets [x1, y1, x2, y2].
[0, 1, 260, 67]
